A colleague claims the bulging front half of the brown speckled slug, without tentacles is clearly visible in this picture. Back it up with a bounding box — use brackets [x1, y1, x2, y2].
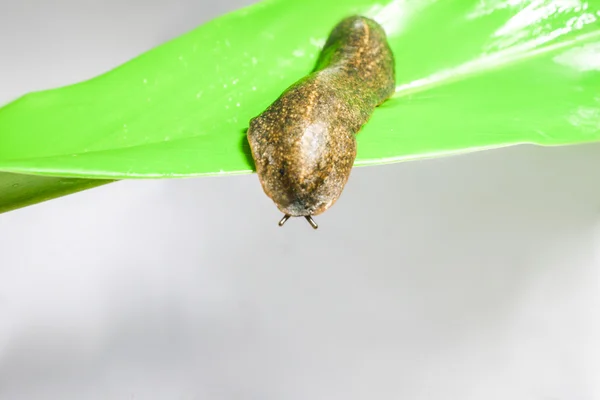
[248, 75, 358, 225]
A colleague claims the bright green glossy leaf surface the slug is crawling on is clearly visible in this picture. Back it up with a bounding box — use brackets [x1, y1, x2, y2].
[0, 0, 600, 212]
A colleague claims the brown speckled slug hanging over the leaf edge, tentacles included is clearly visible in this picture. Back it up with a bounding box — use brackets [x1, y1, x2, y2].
[247, 16, 395, 229]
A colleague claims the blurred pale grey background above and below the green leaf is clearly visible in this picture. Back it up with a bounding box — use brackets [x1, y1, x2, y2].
[0, 0, 600, 400]
